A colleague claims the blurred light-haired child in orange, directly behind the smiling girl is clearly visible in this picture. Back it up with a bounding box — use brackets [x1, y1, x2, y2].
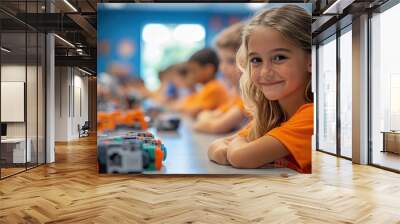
[194, 23, 245, 133]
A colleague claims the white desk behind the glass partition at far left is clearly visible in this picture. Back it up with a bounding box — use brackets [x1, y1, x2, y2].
[1, 138, 32, 163]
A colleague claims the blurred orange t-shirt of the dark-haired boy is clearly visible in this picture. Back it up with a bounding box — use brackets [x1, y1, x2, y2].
[185, 79, 229, 110]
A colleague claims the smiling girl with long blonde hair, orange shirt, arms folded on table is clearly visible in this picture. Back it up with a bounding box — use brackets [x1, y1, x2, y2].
[208, 5, 314, 173]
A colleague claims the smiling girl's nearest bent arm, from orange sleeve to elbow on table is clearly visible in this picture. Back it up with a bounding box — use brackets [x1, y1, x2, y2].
[227, 135, 289, 168]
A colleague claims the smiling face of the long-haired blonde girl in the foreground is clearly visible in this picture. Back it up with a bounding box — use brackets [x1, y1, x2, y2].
[247, 27, 311, 100]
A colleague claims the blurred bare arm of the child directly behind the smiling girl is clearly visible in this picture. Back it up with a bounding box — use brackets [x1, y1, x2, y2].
[194, 107, 244, 134]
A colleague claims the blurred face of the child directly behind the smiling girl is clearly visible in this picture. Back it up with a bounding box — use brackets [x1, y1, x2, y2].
[217, 48, 240, 86]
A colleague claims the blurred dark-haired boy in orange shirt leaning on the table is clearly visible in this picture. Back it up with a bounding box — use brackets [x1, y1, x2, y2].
[180, 48, 228, 117]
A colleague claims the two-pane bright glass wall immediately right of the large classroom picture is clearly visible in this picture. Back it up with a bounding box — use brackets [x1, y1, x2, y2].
[316, 25, 352, 159]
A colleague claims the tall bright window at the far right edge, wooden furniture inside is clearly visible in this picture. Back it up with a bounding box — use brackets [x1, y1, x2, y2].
[370, 4, 400, 170]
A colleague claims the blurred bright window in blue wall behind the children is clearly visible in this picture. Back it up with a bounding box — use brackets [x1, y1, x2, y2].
[140, 24, 205, 90]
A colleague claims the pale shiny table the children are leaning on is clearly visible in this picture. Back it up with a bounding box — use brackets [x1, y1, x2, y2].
[143, 117, 297, 176]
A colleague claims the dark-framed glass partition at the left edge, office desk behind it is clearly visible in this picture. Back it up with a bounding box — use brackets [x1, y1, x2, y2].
[0, 1, 46, 179]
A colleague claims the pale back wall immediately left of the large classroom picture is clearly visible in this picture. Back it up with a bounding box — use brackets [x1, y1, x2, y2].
[55, 67, 88, 141]
